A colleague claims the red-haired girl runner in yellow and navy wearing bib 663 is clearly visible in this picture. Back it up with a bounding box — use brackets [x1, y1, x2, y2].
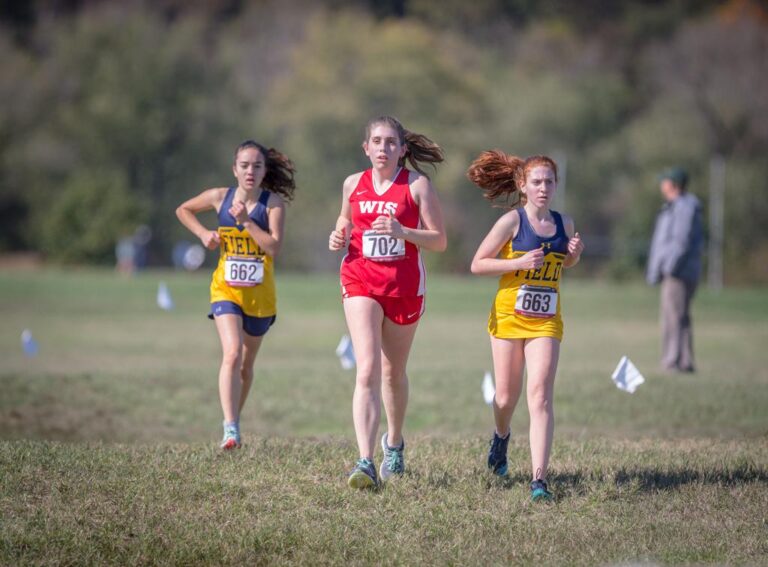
[467, 150, 584, 500]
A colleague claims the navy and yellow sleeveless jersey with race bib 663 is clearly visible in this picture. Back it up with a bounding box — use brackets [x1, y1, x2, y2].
[488, 207, 569, 340]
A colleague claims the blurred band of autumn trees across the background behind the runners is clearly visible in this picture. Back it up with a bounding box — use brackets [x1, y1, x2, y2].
[0, 0, 768, 282]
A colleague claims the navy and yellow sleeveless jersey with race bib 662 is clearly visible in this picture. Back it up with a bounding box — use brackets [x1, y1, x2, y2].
[211, 187, 277, 317]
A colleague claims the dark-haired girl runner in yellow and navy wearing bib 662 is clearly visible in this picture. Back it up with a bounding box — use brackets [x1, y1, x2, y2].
[176, 140, 295, 449]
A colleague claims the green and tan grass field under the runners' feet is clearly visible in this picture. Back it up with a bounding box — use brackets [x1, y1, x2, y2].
[0, 270, 768, 565]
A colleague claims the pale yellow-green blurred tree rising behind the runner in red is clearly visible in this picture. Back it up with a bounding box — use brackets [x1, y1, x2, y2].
[266, 8, 488, 268]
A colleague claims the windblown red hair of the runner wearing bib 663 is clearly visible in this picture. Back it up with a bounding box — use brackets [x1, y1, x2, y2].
[467, 150, 557, 208]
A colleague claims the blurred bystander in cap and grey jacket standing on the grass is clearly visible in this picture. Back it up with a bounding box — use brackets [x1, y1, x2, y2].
[647, 167, 704, 372]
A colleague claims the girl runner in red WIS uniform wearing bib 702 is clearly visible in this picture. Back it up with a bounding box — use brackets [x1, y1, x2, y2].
[328, 116, 447, 488]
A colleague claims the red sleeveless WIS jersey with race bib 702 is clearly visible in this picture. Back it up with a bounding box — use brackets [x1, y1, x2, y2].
[341, 168, 425, 297]
